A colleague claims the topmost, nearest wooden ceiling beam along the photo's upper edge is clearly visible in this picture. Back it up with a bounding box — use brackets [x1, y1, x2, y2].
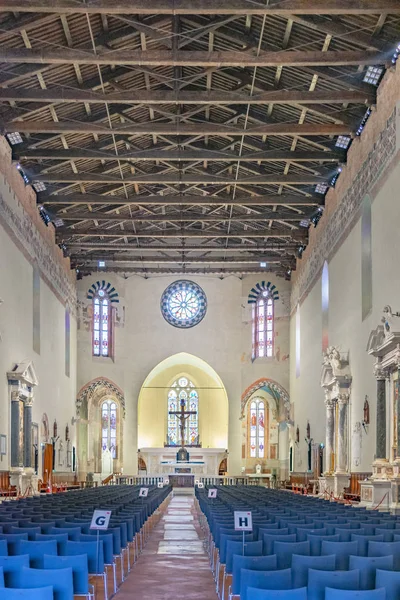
[0, 0, 400, 16]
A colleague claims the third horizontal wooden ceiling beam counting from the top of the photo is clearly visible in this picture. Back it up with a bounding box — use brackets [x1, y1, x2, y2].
[0, 87, 376, 108]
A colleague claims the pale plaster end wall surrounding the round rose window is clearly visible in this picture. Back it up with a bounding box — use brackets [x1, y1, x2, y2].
[78, 273, 290, 474]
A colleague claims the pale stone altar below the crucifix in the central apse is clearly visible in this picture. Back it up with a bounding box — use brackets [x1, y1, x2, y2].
[138, 446, 227, 476]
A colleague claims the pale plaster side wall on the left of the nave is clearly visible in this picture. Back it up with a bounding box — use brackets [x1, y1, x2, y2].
[0, 218, 76, 473]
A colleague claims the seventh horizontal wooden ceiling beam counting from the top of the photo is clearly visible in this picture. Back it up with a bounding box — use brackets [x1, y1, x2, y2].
[38, 192, 323, 206]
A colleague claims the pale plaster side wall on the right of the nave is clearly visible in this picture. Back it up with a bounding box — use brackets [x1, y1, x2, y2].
[290, 158, 400, 472]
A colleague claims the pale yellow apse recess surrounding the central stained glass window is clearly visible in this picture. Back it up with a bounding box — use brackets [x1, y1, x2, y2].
[138, 352, 229, 448]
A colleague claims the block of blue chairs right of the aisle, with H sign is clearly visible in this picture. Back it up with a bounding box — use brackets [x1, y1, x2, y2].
[196, 486, 400, 600]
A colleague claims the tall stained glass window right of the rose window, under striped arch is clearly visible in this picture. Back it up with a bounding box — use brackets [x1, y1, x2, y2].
[252, 290, 274, 359]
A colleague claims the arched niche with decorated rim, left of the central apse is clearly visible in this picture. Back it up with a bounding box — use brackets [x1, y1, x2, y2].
[76, 377, 125, 474]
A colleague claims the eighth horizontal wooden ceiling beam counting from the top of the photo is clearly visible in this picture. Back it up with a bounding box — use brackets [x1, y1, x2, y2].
[55, 210, 306, 223]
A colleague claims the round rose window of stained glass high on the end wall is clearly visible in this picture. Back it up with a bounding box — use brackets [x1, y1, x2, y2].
[161, 280, 207, 329]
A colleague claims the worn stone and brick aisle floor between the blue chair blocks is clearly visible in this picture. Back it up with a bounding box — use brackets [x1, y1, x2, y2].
[116, 495, 217, 600]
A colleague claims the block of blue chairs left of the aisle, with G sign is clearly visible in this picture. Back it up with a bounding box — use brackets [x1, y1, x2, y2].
[0, 486, 171, 600]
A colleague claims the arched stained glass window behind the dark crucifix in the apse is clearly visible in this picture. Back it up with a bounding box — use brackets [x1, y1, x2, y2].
[168, 377, 199, 446]
